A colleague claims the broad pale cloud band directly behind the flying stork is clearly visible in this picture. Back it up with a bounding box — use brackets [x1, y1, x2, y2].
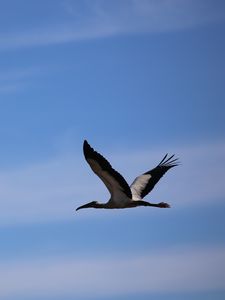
[0, 142, 225, 226]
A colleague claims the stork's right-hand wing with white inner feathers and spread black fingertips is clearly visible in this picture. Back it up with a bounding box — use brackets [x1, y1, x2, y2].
[130, 154, 178, 200]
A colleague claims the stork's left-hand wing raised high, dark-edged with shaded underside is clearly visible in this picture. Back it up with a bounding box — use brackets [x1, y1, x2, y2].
[83, 140, 132, 199]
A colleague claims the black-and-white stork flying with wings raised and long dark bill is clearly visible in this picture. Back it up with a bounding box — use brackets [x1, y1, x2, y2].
[76, 140, 179, 210]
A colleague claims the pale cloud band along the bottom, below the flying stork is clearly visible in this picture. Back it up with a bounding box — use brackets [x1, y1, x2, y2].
[0, 247, 225, 299]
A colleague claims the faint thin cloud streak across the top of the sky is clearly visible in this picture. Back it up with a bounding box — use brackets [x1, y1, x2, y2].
[0, 0, 225, 50]
